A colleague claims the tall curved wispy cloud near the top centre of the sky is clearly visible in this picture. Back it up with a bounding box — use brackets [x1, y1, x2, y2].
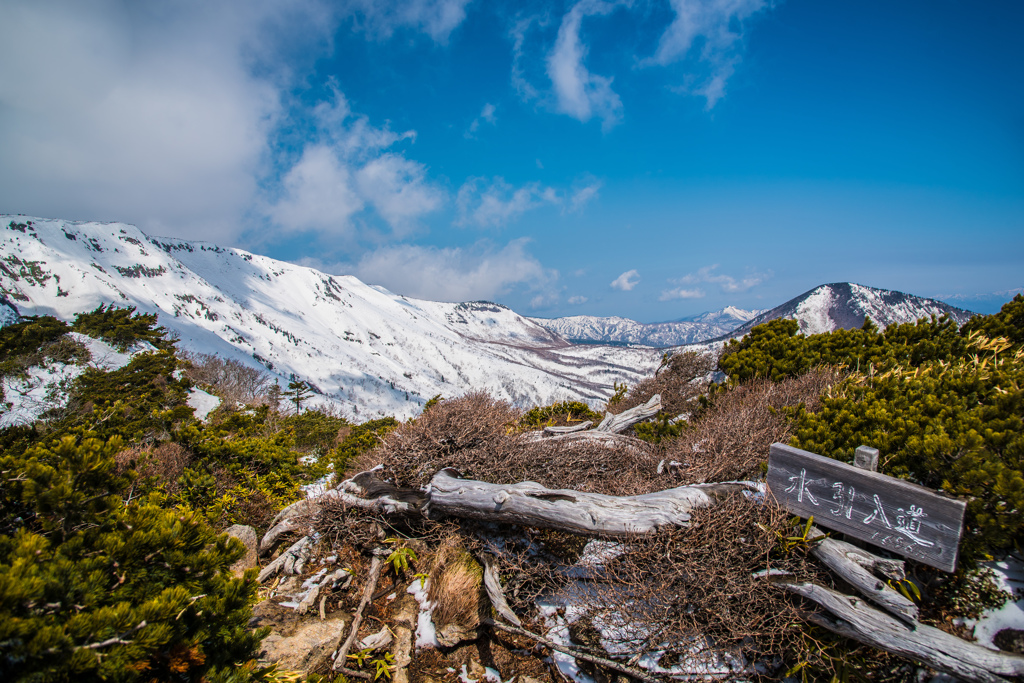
[547, 0, 623, 130]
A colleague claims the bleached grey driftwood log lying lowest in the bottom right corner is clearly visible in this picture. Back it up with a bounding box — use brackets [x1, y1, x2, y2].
[779, 581, 1024, 683]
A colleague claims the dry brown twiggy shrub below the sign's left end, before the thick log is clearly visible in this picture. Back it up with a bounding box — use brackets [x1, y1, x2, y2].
[562, 496, 814, 667]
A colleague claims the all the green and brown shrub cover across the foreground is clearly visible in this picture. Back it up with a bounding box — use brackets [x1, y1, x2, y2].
[0, 296, 1024, 683]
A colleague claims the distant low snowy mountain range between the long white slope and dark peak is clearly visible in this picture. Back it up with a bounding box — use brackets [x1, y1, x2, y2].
[529, 306, 762, 346]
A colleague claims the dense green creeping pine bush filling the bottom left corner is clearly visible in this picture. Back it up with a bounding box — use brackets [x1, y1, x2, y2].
[0, 437, 264, 681]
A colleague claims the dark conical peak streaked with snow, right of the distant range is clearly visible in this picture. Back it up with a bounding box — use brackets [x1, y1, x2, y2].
[725, 283, 975, 337]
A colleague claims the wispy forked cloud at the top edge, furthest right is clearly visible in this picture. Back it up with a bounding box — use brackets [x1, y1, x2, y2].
[647, 0, 770, 110]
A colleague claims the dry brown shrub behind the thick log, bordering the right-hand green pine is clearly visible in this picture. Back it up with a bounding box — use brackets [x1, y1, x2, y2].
[665, 368, 844, 485]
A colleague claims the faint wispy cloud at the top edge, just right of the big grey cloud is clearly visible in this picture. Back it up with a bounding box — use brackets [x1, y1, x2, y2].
[345, 0, 472, 43]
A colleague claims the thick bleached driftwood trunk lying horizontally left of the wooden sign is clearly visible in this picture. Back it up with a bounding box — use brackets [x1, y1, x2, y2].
[341, 468, 755, 536]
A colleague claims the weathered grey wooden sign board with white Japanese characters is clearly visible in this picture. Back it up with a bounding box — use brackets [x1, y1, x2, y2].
[768, 443, 967, 571]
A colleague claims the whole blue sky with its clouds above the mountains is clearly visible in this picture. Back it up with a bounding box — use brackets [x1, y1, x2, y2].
[0, 0, 1024, 322]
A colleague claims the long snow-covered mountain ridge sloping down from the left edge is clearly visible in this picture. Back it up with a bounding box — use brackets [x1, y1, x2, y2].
[0, 215, 660, 420]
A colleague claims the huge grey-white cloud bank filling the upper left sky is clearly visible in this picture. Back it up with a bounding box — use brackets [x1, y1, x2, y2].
[0, 0, 467, 242]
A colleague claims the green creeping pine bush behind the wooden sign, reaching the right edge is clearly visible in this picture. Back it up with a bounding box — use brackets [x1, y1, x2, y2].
[719, 296, 1024, 567]
